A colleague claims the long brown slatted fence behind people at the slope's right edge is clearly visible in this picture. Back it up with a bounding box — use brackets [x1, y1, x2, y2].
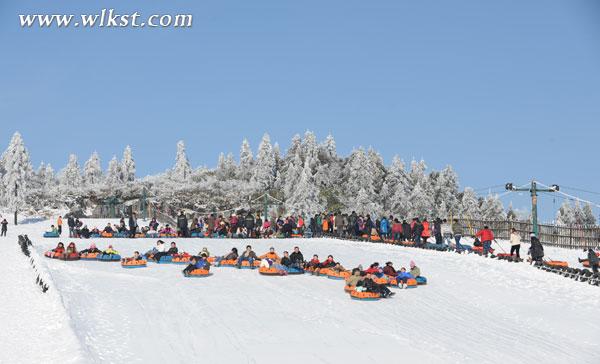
[459, 219, 600, 249]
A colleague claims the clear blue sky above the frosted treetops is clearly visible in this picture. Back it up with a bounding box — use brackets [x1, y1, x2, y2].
[0, 0, 600, 218]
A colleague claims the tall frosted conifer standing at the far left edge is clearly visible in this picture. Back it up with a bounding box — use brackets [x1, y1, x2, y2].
[2, 132, 33, 225]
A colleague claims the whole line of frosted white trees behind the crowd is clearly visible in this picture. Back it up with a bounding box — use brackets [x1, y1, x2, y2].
[0, 131, 592, 220]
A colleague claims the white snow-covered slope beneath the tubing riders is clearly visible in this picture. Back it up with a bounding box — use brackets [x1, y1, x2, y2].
[0, 220, 600, 363]
